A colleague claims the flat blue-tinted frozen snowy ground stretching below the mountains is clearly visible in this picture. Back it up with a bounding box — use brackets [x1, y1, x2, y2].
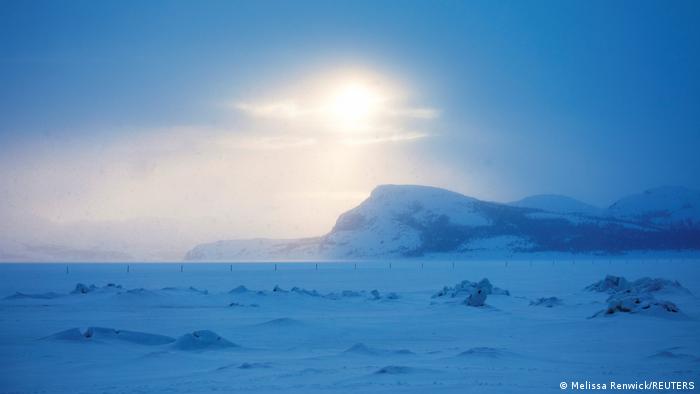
[0, 259, 700, 393]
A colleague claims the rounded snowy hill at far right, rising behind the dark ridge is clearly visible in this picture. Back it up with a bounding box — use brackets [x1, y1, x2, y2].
[607, 186, 700, 228]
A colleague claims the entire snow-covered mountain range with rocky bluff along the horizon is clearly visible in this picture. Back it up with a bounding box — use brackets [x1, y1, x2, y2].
[185, 185, 700, 260]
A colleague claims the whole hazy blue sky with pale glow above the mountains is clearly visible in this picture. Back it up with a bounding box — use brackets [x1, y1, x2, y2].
[0, 0, 700, 260]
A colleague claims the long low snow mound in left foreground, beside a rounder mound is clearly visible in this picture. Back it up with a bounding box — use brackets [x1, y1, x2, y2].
[48, 327, 175, 346]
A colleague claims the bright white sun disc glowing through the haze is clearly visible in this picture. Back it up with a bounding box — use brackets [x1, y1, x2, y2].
[328, 81, 383, 131]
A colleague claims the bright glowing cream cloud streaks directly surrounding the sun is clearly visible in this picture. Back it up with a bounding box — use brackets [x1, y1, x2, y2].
[227, 70, 441, 145]
